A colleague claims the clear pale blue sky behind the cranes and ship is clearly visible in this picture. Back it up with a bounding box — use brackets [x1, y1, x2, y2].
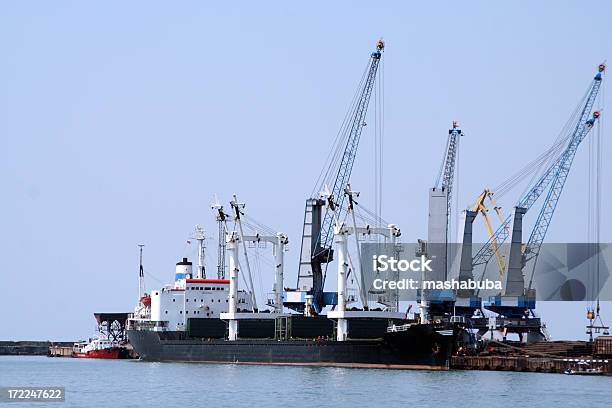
[0, 1, 612, 340]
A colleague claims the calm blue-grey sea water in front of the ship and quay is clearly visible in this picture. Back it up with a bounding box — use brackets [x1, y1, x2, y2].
[0, 356, 612, 408]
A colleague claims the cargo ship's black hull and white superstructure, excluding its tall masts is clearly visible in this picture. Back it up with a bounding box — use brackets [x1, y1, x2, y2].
[127, 259, 461, 369]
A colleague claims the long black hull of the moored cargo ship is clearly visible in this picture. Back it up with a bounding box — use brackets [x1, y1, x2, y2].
[128, 325, 456, 370]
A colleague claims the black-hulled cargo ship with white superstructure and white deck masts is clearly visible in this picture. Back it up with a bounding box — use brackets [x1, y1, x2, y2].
[127, 200, 470, 370]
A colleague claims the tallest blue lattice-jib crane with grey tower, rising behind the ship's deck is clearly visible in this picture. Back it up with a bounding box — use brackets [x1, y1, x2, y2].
[286, 40, 385, 313]
